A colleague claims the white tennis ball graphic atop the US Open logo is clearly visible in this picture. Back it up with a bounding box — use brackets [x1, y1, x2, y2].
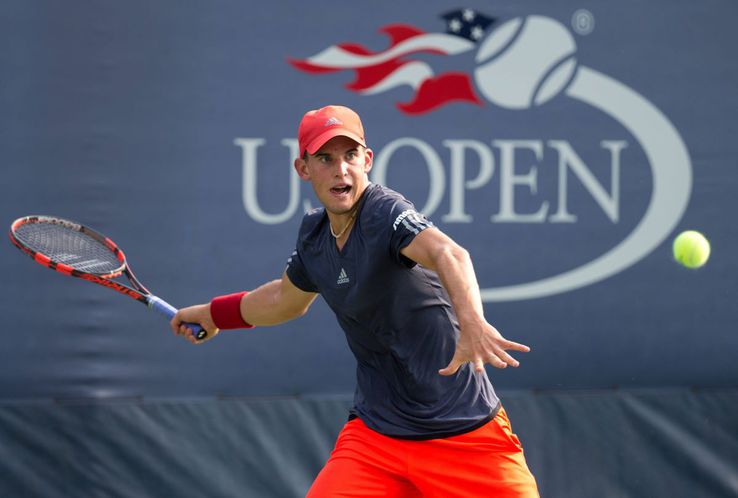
[474, 16, 577, 109]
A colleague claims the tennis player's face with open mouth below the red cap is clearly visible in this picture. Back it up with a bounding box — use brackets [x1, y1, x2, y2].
[295, 136, 373, 215]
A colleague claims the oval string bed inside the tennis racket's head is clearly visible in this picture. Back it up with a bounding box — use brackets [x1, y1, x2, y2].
[15, 223, 123, 275]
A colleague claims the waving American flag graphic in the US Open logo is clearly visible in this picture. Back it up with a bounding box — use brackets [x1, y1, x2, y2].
[289, 9, 495, 114]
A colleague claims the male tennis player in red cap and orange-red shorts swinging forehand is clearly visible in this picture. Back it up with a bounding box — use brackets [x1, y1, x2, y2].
[171, 106, 538, 498]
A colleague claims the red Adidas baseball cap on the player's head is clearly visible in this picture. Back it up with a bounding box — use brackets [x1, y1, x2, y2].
[297, 105, 366, 157]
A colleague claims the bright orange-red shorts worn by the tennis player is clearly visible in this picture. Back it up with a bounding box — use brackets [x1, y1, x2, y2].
[307, 408, 539, 498]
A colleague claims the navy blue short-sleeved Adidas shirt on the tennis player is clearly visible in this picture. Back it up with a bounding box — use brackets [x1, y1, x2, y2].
[287, 184, 499, 439]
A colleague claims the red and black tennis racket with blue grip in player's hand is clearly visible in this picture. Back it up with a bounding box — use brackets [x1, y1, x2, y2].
[9, 216, 208, 340]
